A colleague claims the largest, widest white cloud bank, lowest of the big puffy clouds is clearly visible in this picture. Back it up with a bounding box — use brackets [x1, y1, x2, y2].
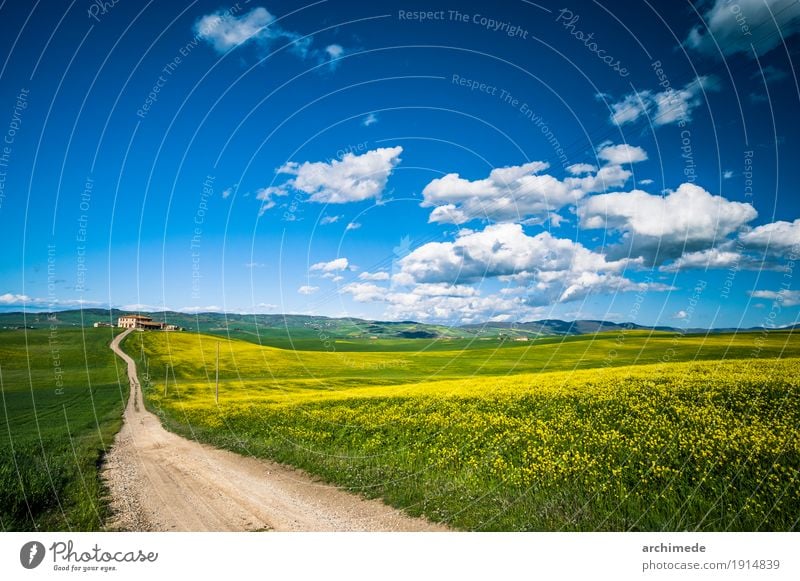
[340, 223, 671, 323]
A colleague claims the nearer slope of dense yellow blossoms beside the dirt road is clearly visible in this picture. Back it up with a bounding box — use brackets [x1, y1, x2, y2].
[136, 326, 800, 531]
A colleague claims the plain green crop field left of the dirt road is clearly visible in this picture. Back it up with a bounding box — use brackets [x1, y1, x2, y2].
[0, 329, 128, 531]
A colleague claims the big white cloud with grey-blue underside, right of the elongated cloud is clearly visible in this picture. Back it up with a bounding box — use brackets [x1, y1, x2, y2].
[578, 183, 758, 264]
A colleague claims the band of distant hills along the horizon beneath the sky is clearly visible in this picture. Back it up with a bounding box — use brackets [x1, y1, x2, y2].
[0, 309, 800, 340]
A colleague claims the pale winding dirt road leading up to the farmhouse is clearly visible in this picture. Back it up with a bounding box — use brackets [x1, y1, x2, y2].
[103, 331, 446, 531]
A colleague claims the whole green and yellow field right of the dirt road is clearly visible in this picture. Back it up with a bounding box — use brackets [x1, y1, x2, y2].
[130, 331, 800, 530]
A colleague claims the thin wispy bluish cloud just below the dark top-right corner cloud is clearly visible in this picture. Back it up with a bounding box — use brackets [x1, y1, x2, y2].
[610, 76, 719, 127]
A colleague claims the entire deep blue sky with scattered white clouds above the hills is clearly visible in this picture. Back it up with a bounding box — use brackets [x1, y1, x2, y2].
[0, 0, 800, 327]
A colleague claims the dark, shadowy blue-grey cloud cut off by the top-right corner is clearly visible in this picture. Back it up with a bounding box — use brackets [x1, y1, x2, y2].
[684, 0, 800, 58]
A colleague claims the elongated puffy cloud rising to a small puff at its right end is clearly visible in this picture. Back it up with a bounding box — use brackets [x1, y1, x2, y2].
[420, 144, 647, 224]
